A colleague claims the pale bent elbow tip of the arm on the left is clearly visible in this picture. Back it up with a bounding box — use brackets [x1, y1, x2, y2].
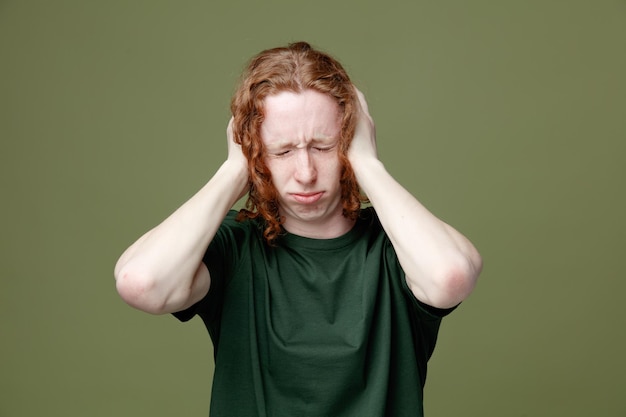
[115, 269, 165, 315]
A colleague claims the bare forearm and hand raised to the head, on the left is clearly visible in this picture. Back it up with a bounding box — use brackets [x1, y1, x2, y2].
[114, 119, 248, 314]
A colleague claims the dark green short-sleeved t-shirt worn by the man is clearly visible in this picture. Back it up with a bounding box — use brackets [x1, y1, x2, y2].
[176, 208, 450, 417]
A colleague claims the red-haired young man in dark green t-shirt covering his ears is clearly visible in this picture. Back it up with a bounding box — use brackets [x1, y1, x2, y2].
[115, 42, 482, 417]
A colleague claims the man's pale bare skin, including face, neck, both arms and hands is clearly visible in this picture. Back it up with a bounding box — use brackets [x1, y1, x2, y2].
[115, 90, 482, 314]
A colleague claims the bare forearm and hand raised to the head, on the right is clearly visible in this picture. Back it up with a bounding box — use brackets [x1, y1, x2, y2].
[348, 90, 482, 308]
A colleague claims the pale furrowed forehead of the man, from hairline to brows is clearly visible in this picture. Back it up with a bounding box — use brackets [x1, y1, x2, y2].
[261, 90, 341, 145]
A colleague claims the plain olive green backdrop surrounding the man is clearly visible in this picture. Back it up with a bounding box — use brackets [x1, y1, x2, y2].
[0, 0, 626, 417]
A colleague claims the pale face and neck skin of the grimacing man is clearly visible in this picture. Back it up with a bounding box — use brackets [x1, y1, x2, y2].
[261, 90, 353, 238]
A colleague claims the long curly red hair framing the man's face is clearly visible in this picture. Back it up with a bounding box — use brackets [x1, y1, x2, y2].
[230, 42, 365, 244]
